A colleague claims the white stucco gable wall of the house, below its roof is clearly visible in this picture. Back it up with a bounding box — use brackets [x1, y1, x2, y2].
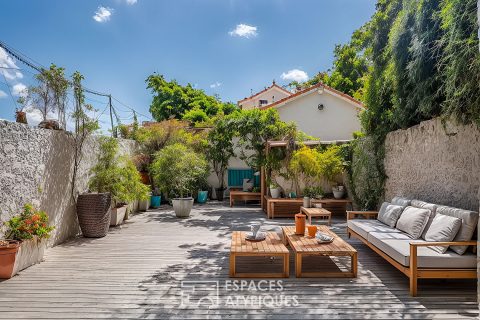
[275, 90, 361, 141]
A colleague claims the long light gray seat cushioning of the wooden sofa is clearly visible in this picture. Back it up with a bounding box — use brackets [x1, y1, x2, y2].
[368, 232, 477, 269]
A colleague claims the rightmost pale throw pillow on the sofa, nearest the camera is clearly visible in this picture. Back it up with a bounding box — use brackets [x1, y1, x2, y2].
[425, 214, 462, 253]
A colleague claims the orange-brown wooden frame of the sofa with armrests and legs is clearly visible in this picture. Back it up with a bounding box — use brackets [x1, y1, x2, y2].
[347, 211, 477, 297]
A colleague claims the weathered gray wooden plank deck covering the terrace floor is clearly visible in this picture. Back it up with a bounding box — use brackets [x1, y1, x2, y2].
[0, 203, 478, 319]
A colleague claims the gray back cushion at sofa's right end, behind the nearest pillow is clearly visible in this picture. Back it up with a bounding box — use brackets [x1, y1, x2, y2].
[436, 206, 478, 254]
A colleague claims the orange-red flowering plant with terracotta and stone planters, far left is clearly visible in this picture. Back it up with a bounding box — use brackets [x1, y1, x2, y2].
[0, 204, 55, 278]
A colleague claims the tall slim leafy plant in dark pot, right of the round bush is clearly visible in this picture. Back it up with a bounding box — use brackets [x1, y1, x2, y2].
[205, 116, 235, 201]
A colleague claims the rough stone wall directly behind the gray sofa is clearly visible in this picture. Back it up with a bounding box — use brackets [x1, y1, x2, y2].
[385, 118, 480, 211]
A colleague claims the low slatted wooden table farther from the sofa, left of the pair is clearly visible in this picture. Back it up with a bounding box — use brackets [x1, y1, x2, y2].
[230, 231, 290, 278]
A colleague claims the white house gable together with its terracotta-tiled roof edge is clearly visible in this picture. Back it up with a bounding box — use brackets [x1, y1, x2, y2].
[239, 83, 365, 141]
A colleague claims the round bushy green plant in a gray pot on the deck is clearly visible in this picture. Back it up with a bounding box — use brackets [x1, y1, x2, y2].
[152, 143, 209, 218]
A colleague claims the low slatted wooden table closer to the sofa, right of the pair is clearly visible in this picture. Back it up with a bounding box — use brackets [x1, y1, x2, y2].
[282, 226, 357, 278]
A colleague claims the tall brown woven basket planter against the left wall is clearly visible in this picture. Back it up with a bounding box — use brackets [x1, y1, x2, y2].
[77, 193, 112, 238]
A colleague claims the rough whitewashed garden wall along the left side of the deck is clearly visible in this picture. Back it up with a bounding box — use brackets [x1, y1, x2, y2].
[0, 121, 135, 245]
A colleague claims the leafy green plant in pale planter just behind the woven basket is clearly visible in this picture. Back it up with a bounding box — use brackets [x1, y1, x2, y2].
[87, 137, 148, 231]
